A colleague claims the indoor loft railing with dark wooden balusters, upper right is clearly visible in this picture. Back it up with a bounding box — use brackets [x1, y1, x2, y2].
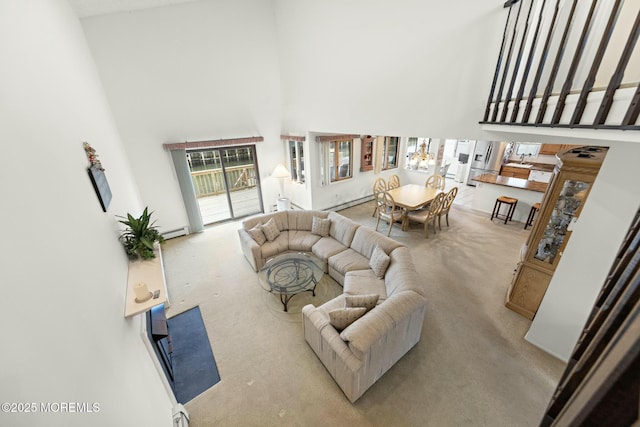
[480, 0, 640, 130]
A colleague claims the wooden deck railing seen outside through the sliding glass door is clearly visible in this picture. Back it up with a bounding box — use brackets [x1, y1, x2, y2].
[191, 165, 256, 198]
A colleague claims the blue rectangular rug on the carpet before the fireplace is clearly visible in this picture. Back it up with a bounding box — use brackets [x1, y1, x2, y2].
[167, 307, 220, 403]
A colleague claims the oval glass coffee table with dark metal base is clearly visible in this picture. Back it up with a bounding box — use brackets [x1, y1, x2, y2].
[258, 252, 324, 311]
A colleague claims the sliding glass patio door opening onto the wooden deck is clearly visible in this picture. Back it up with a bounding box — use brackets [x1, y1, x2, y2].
[187, 145, 264, 225]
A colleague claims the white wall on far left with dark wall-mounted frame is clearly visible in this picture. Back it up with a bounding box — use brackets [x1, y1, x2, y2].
[0, 0, 172, 426]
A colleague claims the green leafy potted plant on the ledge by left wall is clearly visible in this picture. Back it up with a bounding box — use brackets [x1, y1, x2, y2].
[118, 207, 164, 259]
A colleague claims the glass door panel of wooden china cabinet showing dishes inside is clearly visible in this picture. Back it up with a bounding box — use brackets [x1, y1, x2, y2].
[534, 179, 591, 264]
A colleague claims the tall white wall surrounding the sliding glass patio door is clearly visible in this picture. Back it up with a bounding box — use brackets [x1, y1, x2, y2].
[83, 0, 286, 230]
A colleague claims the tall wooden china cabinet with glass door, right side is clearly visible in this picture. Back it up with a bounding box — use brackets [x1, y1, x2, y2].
[505, 146, 608, 319]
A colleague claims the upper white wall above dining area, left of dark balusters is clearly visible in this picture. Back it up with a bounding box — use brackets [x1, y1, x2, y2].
[276, 0, 507, 139]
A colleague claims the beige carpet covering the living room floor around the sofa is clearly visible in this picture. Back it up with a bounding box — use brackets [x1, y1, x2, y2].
[163, 203, 564, 427]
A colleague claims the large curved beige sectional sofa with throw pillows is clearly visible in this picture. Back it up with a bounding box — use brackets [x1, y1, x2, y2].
[238, 210, 426, 402]
